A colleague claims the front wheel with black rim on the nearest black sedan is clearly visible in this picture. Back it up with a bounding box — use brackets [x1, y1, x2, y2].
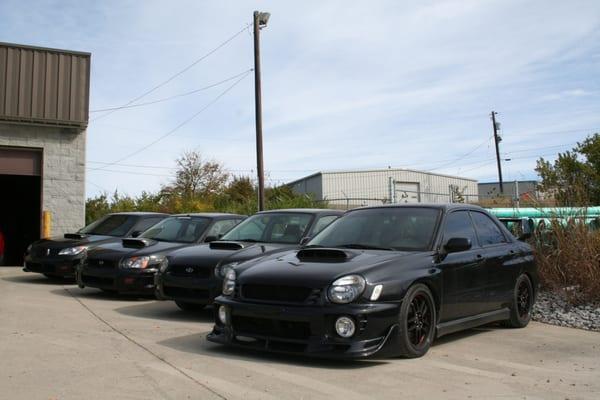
[398, 283, 437, 358]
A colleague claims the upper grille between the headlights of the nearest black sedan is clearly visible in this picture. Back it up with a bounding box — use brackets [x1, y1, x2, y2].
[241, 284, 321, 304]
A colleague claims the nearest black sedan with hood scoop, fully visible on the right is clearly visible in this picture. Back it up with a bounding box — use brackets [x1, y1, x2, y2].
[208, 205, 538, 358]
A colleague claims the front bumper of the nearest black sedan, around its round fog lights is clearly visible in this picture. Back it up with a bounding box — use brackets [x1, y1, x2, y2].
[208, 296, 400, 359]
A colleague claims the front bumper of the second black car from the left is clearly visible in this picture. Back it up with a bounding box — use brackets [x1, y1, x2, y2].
[76, 267, 157, 295]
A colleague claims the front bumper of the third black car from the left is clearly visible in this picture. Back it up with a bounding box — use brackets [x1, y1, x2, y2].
[155, 271, 222, 304]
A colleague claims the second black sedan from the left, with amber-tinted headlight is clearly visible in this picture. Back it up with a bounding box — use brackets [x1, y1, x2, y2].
[77, 213, 245, 295]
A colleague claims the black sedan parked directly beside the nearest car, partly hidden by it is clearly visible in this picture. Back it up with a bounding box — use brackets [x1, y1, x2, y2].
[156, 209, 343, 311]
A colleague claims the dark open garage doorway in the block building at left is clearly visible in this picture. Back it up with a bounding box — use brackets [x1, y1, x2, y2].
[0, 148, 42, 266]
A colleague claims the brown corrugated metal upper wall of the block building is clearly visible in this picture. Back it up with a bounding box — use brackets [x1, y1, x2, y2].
[0, 43, 90, 127]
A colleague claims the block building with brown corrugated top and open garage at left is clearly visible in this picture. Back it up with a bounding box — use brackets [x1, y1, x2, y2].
[0, 43, 90, 265]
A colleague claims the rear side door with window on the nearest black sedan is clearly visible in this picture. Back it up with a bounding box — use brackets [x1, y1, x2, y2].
[471, 211, 520, 311]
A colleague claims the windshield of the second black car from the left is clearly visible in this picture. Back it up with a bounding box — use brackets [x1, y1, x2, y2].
[139, 217, 210, 243]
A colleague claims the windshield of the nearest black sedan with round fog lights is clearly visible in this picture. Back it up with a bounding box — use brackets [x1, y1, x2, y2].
[307, 207, 440, 251]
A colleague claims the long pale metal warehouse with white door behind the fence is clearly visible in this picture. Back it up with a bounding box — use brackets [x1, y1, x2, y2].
[288, 169, 477, 208]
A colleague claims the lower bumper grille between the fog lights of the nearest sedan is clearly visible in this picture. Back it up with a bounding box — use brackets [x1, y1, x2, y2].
[231, 315, 310, 340]
